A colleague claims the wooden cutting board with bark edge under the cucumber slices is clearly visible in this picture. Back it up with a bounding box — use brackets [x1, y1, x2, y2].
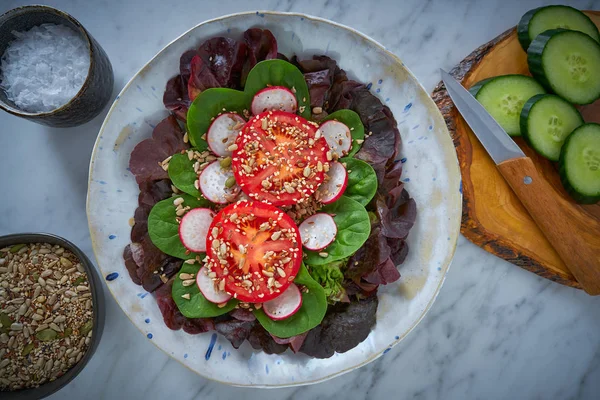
[432, 11, 600, 288]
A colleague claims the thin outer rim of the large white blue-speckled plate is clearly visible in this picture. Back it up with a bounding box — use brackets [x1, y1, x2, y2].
[86, 11, 462, 388]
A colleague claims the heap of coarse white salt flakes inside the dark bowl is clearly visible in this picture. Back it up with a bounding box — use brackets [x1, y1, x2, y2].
[0, 24, 90, 113]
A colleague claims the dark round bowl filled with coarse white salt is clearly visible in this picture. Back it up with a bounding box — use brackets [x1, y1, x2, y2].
[0, 5, 114, 127]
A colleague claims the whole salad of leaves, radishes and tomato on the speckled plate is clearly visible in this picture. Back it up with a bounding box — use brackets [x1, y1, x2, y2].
[123, 28, 416, 357]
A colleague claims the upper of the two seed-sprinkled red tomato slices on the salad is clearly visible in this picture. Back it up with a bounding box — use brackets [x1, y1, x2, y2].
[232, 111, 331, 206]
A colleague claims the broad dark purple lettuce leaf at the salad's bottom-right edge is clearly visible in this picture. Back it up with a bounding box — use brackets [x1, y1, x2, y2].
[300, 296, 378, 358]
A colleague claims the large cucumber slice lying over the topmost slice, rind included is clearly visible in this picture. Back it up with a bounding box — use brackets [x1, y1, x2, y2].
[527, 29, 600, 104]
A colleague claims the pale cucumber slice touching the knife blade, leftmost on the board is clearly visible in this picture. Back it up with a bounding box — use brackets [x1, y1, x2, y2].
[469, 75, 546, 136]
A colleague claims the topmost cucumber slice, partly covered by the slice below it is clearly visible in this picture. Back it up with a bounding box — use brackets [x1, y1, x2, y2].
[517, 5, 600, 51]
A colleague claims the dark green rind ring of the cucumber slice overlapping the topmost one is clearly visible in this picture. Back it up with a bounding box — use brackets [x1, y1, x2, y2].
[527, 29, 600, 104]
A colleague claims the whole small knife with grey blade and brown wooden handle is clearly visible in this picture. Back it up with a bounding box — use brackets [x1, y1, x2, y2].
[441, 70, 600, 295]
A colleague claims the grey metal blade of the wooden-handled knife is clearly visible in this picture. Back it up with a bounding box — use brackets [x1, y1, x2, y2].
[440, 69, 525, 164]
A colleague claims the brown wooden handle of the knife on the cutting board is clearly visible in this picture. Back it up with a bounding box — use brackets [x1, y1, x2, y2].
[498, 157, 600, 295]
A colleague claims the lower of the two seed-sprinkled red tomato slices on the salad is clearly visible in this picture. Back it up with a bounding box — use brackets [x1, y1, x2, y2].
[206, 201, 302, 303]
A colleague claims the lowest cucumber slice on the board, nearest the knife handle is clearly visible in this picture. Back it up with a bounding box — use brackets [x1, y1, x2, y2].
[559, 123, 600, 204]
